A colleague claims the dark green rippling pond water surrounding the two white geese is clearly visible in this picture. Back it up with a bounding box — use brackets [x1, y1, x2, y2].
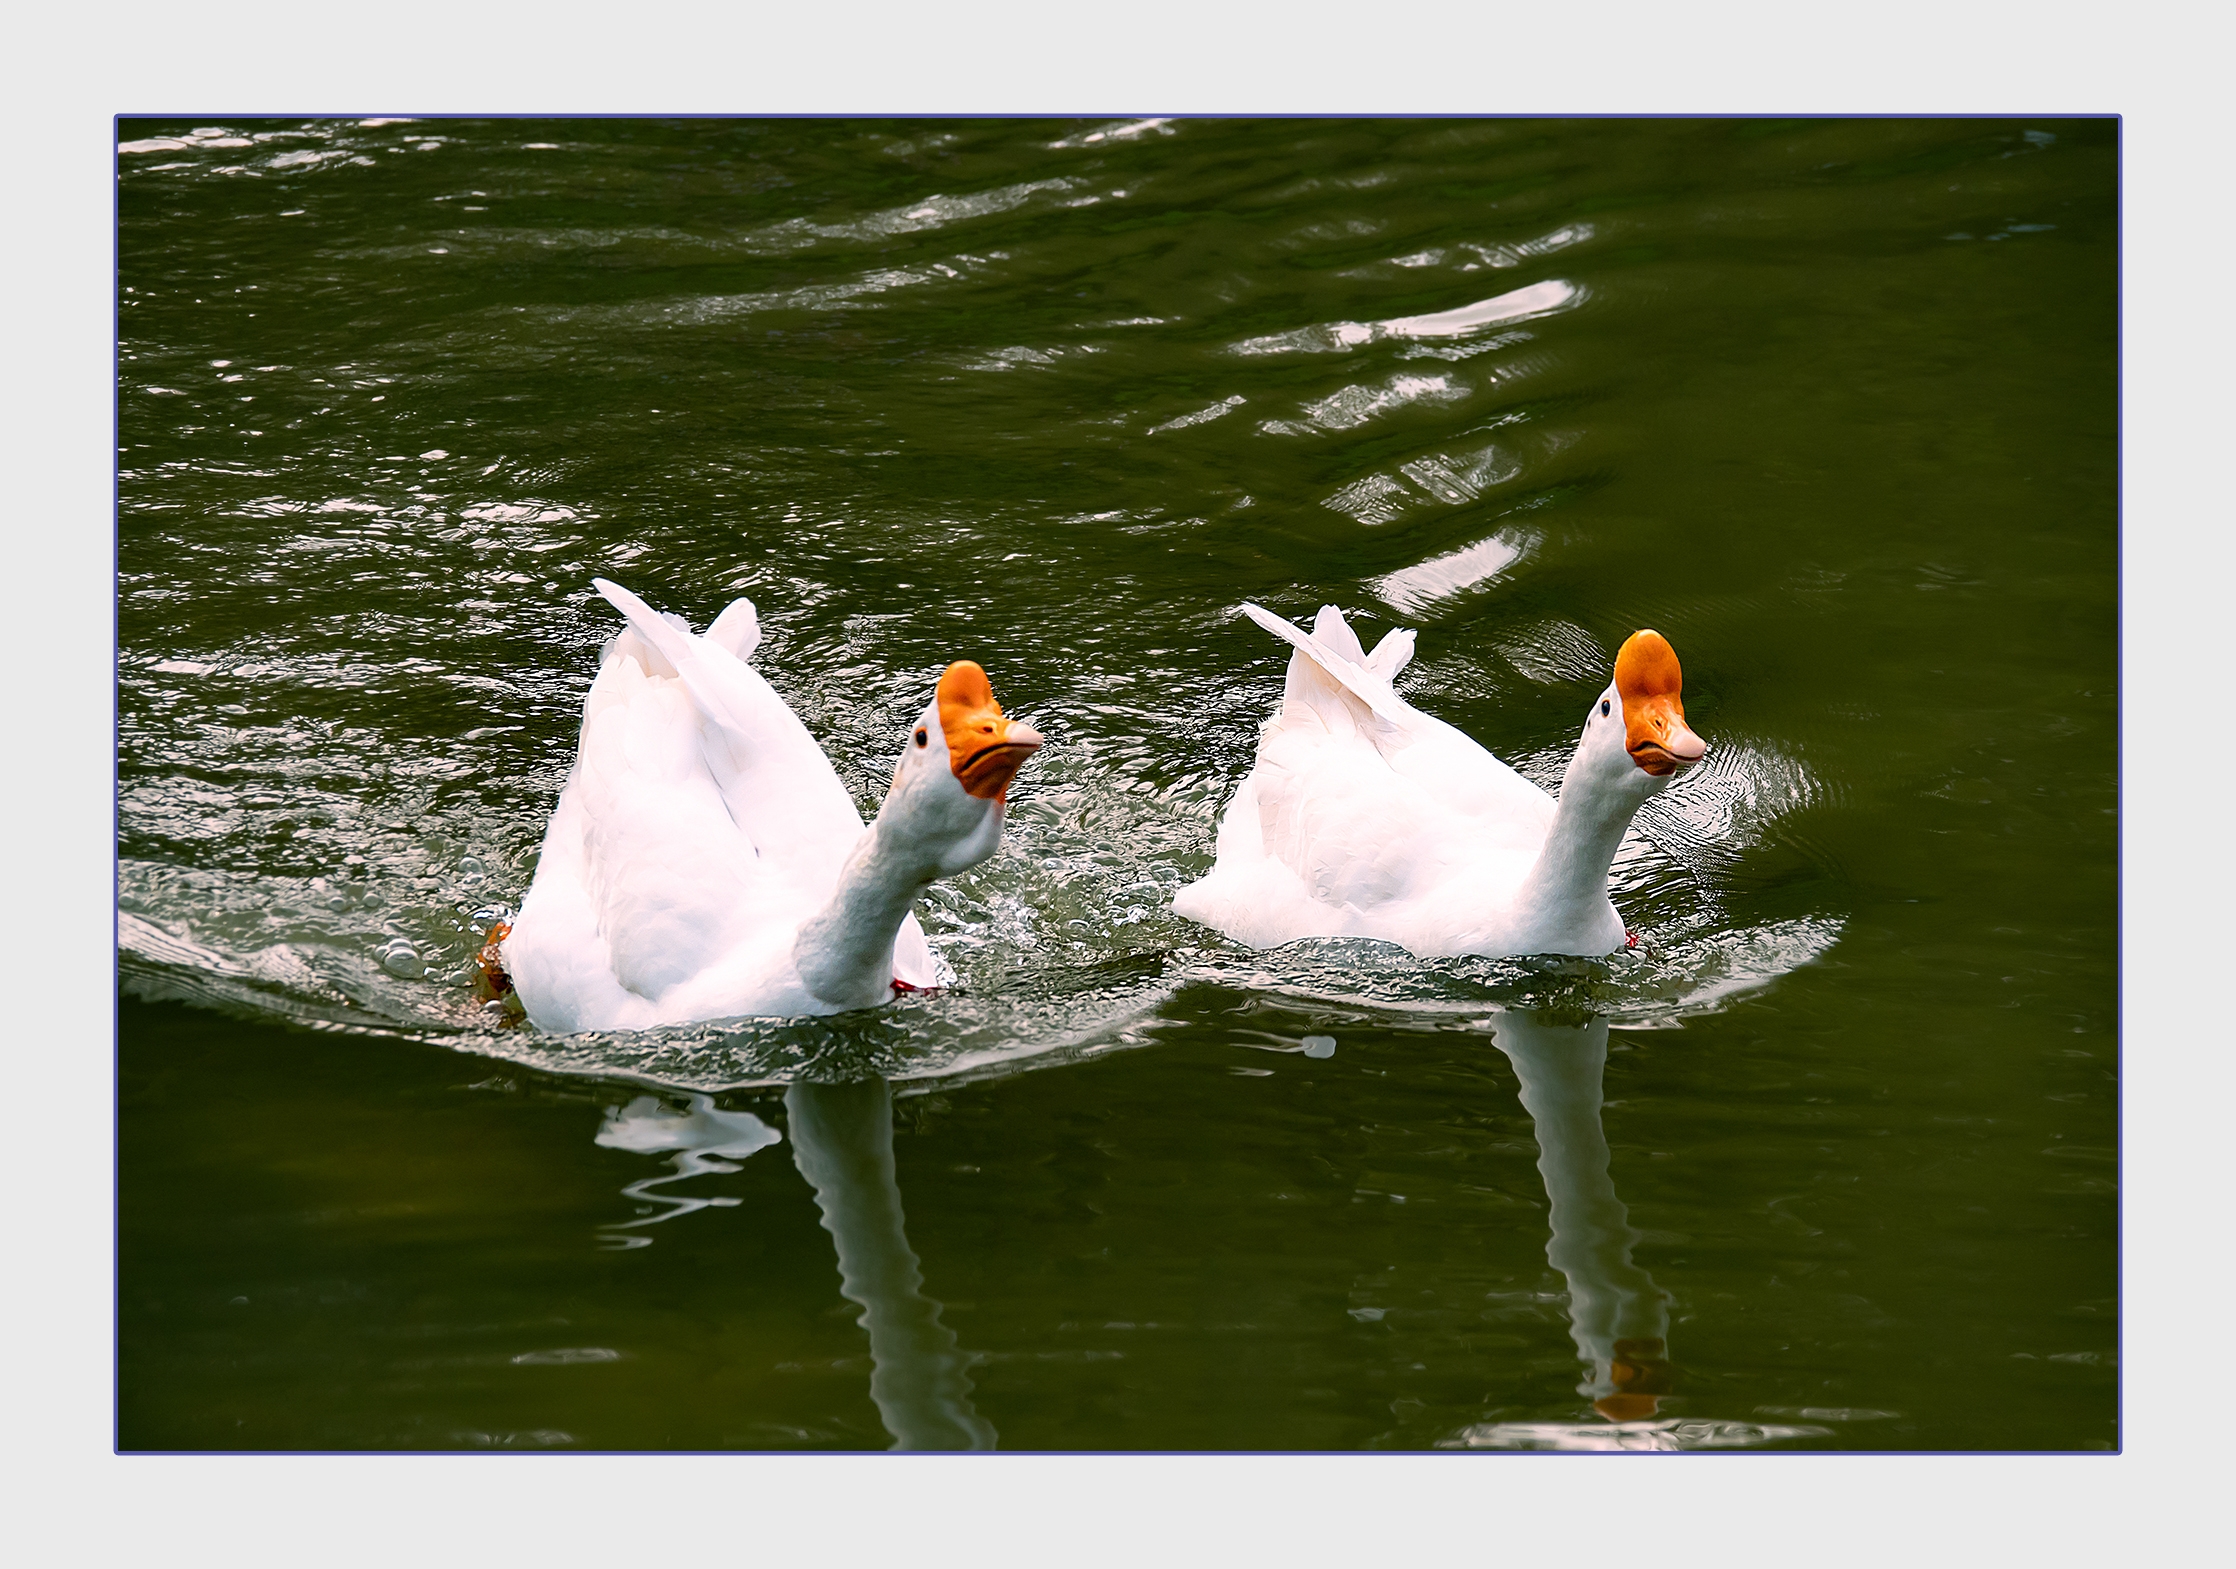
[116, 121, 2120, 1448]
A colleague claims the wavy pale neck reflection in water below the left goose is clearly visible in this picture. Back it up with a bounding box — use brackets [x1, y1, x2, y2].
[785, 1080, 995, 1448]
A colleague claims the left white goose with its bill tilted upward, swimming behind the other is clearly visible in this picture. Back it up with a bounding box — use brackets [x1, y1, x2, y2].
[492, 579, 1040, 1030]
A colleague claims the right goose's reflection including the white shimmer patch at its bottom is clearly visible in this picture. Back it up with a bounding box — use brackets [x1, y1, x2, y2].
[1442, 1012, 1827, 1448]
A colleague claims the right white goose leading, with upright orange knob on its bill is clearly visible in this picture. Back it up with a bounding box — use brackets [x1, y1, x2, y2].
[1172, 603, 1708, 957]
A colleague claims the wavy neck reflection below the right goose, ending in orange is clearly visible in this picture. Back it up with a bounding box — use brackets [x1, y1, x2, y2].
[1494, 1012, 1668, 1419]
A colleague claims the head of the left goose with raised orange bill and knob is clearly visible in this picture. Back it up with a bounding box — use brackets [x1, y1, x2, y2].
[877, 659, 1040, 876]
